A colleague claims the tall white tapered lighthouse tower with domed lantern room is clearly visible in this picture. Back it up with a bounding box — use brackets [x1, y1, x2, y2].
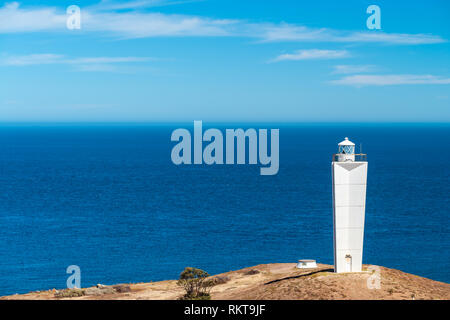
[331, 138, 367, 273]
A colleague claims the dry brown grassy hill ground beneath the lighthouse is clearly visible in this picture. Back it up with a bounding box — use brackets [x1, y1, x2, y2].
[0, 263, 450, 300]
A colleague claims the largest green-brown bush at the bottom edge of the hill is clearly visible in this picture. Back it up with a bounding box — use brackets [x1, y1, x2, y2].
[177, 267, 214, 300]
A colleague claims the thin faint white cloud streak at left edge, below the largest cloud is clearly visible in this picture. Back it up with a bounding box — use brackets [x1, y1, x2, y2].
[0, 53, 157, 71]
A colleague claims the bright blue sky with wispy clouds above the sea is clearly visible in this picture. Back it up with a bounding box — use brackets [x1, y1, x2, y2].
[0, 0, 450, 123]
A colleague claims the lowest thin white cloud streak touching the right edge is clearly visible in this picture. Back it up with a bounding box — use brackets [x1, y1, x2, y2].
[331, 74, 450, 87]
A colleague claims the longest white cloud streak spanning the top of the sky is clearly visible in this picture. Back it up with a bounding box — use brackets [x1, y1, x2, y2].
[0, 0, 446, 45]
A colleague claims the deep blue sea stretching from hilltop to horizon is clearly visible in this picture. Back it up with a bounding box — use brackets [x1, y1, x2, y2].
[0, 123, 450, 295]
